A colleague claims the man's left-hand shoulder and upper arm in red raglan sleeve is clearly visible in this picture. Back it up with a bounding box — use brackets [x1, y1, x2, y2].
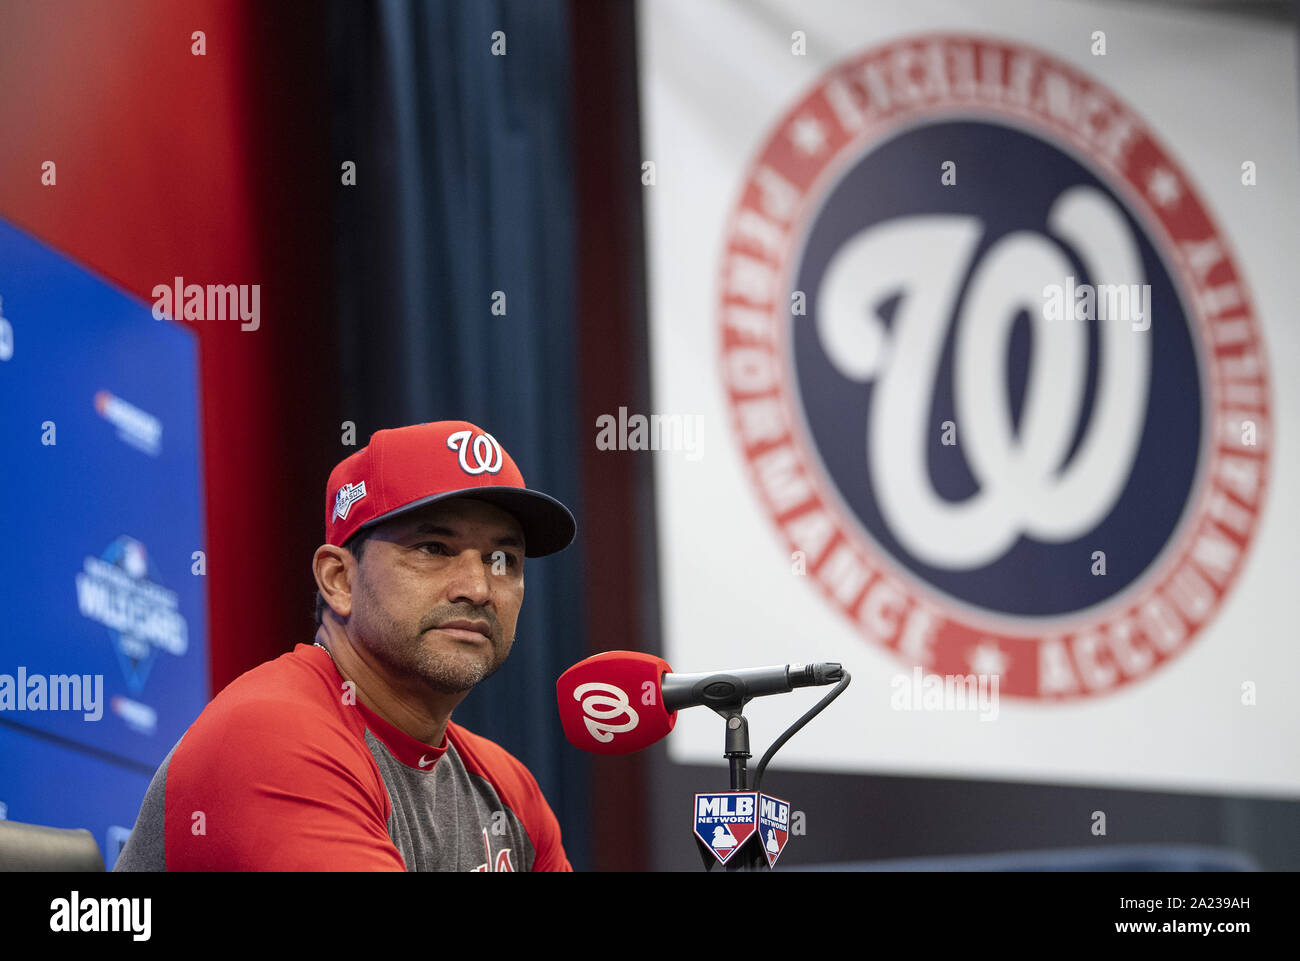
[129, 645, 404, 871]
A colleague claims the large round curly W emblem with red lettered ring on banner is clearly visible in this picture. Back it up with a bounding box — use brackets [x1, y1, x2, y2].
[719, 34, 1274, 700]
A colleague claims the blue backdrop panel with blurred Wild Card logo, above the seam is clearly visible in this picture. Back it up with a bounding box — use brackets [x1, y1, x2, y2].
[0, 214, 208, 769]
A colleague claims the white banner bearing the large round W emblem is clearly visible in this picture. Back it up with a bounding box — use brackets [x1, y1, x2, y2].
[639, 0, 1300, 796]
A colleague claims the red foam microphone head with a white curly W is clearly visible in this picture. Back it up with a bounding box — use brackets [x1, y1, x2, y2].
[555, 650, 677, 754]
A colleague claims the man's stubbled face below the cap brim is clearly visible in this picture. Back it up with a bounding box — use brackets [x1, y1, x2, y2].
[348, 498, 524, 694]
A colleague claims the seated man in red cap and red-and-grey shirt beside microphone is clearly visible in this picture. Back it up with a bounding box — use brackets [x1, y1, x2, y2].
[114, 421, 576, 871]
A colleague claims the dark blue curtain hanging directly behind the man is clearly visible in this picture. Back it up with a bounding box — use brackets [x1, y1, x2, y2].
[322, 0, 589, 870]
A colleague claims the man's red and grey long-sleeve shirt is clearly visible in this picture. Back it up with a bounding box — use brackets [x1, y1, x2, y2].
[114, 644, 572, 871]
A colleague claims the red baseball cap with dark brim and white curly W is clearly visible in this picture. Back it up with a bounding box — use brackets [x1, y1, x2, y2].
[325, 420, 577, 558]
